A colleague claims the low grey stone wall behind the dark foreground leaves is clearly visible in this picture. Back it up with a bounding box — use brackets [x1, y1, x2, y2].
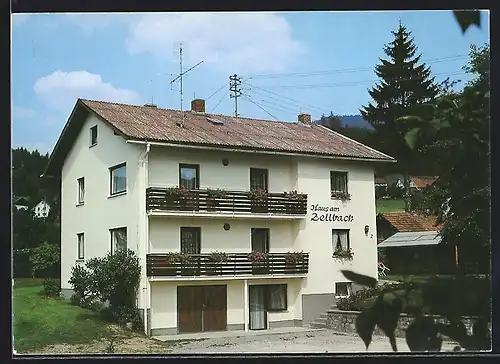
[326, 310, 475, 337]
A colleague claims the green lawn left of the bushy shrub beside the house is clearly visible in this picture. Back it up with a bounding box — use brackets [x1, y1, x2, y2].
[13, 279, 109, 353]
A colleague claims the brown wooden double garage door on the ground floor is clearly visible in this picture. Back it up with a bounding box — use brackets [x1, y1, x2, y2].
[177, 285, 227, 333]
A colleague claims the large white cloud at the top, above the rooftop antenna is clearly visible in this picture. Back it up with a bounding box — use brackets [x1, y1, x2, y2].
[125, 12, 305, 73]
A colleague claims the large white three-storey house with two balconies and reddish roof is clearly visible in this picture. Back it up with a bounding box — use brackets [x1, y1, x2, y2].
[44, 99, 394, 335]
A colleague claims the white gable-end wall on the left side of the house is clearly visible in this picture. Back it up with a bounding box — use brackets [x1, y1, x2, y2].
[61, 116, 145, 298]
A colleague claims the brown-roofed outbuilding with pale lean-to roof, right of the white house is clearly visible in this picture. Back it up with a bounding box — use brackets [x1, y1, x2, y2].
[377, 212, 456, 274]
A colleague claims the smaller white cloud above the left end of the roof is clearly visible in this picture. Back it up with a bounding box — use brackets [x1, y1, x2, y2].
[33, 71, 142, 113]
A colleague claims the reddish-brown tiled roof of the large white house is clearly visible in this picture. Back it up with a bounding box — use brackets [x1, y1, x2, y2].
[80, 99, 394, 161]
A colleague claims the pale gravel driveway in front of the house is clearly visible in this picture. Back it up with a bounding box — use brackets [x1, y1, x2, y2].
[166, 330, 455, 354]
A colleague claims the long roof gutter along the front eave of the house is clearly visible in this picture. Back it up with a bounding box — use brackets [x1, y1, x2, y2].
[126, 139, 397, 163]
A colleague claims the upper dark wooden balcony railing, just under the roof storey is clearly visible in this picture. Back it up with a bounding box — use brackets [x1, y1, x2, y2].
[146, 187, 307, 215]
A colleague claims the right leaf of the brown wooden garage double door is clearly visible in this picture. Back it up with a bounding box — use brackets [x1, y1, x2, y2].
[203, 286, 227, 331]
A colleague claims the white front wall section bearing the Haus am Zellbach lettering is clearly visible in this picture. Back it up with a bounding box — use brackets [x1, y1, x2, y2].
[295, 159, 377, 293]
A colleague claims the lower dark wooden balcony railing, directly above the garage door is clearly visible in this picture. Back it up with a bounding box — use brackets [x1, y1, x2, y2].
[146, 253, 309, 277]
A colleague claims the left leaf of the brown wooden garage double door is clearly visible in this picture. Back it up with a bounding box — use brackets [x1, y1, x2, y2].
[177, 286, 203, 333]
